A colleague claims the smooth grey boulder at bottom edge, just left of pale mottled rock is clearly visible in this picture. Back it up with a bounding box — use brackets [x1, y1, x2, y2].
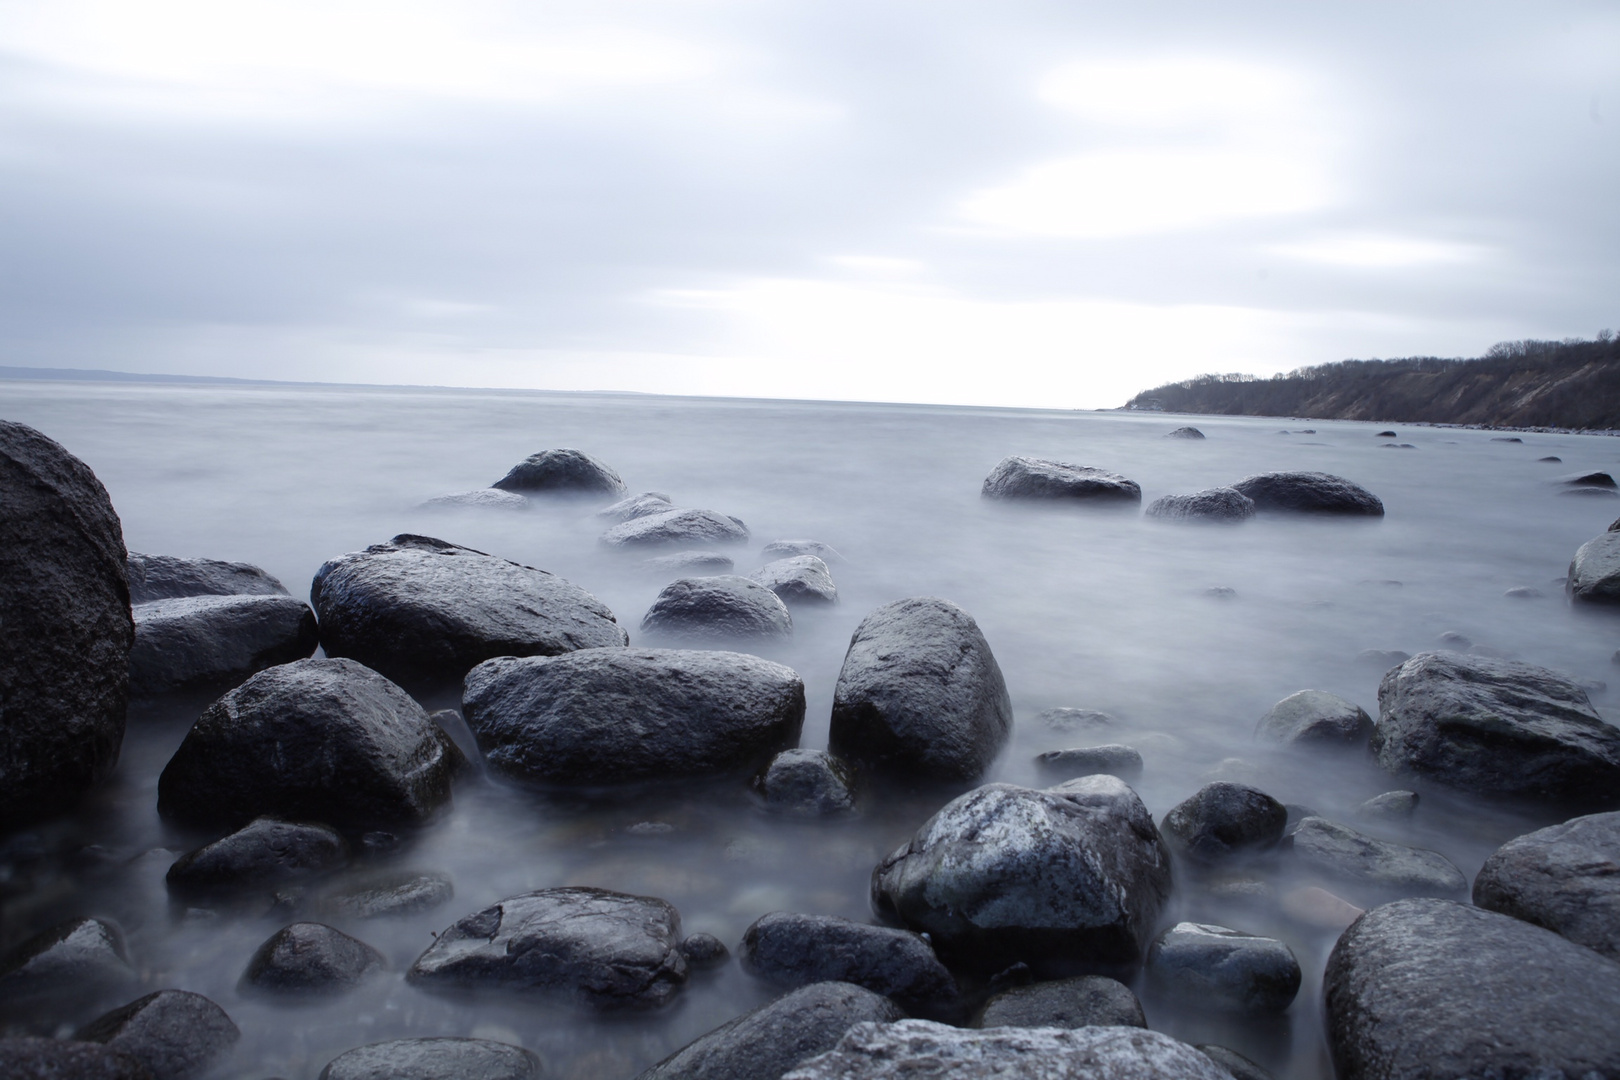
[637, 983, 906, 1080]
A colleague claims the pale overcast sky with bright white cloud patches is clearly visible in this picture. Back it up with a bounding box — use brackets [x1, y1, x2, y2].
[0, 0, 1620, 408]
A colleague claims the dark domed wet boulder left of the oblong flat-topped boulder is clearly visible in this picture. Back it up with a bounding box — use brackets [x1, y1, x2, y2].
[157, 659, 463, 829]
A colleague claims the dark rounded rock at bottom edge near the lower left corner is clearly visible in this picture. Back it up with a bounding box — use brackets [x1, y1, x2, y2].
[73, 989, 241, 1080]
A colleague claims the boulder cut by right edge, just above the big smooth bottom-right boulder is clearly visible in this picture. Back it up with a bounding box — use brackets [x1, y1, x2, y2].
[1474, 811, 1620, 960]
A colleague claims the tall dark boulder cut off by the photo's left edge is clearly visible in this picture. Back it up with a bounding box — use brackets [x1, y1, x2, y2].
[0, 419, 134, 831]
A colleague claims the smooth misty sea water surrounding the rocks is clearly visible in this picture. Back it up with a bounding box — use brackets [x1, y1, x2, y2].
[0, 375, 1620, 1080]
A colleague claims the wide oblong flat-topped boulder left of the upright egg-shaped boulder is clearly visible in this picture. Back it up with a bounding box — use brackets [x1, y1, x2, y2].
[462, 649, 805, 784]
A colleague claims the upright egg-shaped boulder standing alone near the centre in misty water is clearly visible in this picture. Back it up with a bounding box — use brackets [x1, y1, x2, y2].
[828, 596, 1013, 780]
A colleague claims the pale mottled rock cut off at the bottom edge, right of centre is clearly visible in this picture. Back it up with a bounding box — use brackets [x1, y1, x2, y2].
[782, 1020, 1231, 1080]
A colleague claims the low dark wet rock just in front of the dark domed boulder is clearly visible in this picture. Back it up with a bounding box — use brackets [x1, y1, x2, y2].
[165, 818, 348, 895]
